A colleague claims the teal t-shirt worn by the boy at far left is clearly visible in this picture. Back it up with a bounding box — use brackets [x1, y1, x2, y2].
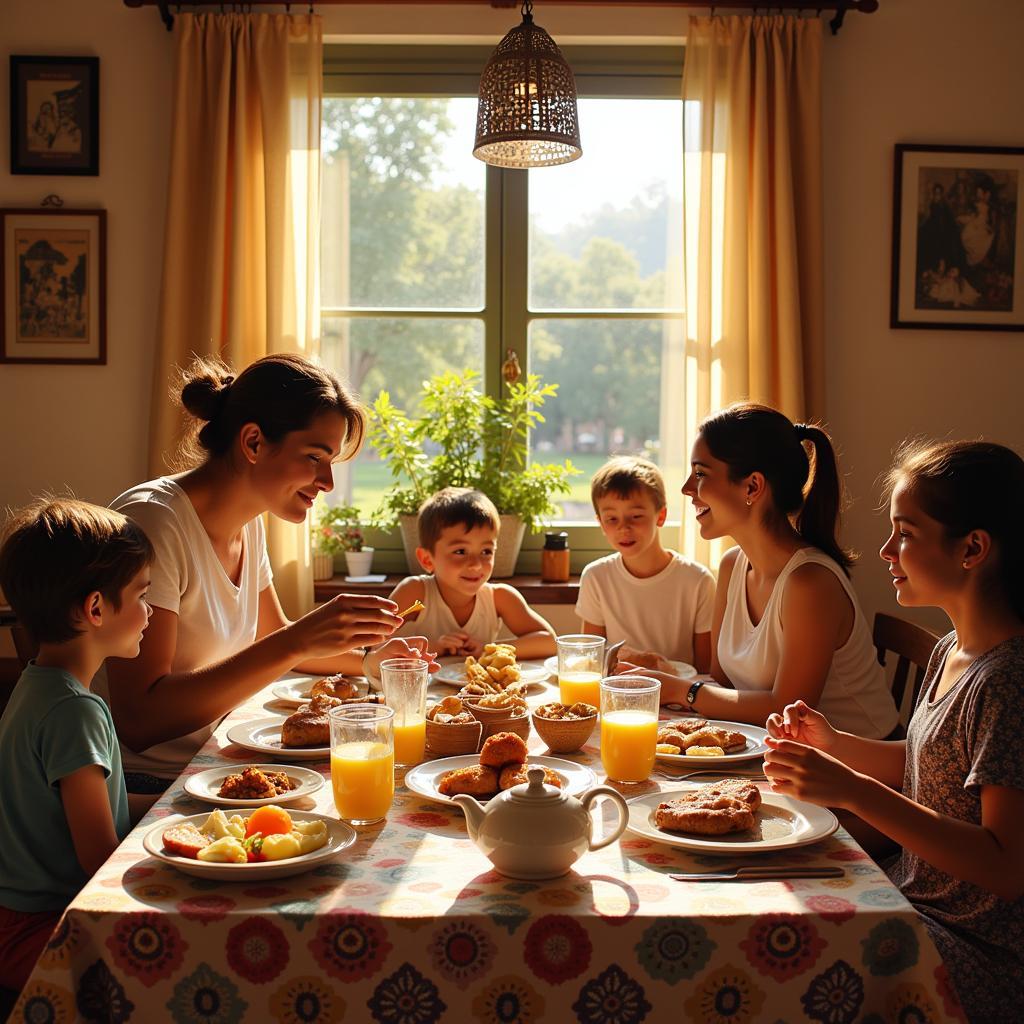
[0, 663, 131, 910]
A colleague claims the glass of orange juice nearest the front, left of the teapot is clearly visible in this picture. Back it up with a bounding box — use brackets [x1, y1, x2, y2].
[330, 705, 394, 825]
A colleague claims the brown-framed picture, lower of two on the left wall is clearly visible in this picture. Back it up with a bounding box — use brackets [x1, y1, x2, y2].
[0, 210, 106, 364]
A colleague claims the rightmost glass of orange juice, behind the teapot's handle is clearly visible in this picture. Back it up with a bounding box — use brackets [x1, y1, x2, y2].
[601, 676, 662, 782]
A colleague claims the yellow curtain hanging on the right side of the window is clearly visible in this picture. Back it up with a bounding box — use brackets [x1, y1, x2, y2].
[681, 16, 824, 565]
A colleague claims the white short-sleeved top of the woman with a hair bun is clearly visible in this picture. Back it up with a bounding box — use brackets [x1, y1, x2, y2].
[92, 476, 273, 779]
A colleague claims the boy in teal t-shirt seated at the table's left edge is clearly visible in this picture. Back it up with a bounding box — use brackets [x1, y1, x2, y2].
[0, 500, 153, 989]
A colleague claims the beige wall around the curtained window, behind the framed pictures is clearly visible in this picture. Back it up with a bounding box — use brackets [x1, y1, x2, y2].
[0, 0, 1024, 627]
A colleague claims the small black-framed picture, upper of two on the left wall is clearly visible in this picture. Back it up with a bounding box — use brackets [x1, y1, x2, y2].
[10, 55, 99, 175]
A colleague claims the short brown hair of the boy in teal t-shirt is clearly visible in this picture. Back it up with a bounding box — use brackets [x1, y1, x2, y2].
[0, 498, 153, 643]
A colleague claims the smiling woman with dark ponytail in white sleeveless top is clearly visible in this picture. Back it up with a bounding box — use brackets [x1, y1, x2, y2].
[614, 403, 899, 738]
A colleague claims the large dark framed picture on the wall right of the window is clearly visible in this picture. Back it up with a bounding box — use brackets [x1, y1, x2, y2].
[890, 145, 1024, 331]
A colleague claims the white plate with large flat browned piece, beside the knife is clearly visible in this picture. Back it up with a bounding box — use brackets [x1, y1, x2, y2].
[626, 778, 839, 855]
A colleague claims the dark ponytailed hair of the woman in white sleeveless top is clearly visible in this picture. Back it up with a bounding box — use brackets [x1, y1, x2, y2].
[700, 402, 856, 575]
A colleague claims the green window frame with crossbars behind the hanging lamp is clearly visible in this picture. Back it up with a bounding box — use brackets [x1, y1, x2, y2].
[321, 44, 683, 573]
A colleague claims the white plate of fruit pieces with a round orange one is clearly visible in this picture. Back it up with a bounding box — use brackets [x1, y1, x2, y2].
[142, 805, 356, 882]
